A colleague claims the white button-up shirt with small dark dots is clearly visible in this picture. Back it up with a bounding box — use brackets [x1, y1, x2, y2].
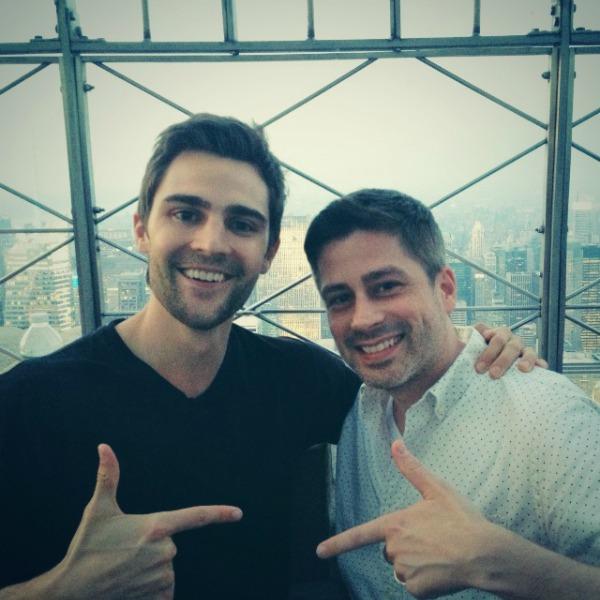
[335, 332, 600, 600]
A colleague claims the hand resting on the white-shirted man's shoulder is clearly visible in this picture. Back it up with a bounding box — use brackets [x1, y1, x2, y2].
[474, 323, 548, 379]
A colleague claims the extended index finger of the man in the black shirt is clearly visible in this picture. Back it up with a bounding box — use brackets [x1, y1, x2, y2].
[148, 505, 242, 538]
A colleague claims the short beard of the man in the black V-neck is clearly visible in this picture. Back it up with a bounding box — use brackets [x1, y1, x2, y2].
[148, 251, 259, 331]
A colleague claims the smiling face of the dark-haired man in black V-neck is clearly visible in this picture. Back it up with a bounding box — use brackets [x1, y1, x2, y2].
[134, 152, 278, 330]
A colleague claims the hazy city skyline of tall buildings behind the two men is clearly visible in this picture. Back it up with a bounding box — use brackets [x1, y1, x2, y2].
[0, 195, 600, 400]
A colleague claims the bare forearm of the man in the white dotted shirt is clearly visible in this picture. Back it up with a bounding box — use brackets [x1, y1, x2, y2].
[474, 527, 600, 600]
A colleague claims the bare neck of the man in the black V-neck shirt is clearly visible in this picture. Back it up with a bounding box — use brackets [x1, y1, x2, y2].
[117, 296, 231, 398]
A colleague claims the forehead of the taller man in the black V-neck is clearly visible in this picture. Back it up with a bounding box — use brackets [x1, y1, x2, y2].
[154, 152, 269, 217]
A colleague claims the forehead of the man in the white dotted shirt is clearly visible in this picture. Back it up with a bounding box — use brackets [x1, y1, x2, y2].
[318, 231, 427, 289]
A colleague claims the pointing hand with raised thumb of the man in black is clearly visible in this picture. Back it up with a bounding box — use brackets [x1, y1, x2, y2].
[24, 444, 242, 600]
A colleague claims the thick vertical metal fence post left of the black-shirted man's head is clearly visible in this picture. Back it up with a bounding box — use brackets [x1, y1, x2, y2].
[56, 0, 101, 334]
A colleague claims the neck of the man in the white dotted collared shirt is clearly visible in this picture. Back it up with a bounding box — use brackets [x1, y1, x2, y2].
[391, 327, 465, 434]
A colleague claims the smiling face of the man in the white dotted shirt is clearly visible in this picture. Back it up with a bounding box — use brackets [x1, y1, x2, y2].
[317, 231, 457, 397]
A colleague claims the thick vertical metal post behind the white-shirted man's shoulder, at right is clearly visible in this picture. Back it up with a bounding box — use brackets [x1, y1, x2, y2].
[541, 0, 575, 371]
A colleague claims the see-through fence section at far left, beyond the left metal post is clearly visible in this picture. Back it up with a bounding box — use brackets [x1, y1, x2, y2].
[0, 59, 80, 371]
